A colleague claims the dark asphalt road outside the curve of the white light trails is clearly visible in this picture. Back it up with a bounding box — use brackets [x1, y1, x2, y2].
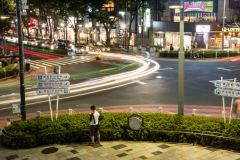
[0, 56, 240, 117]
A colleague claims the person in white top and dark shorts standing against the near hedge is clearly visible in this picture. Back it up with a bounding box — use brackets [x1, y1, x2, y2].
[89, 105, 100, 146]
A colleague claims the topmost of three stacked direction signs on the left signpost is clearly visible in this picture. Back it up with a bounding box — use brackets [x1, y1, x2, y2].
[37, 73, 70, 81]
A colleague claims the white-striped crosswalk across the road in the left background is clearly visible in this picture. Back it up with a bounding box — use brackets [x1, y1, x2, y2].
[31, 56, 95, 69]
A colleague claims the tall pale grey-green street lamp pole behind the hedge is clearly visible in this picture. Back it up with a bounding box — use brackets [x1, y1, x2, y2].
[169, 0, 185, 115]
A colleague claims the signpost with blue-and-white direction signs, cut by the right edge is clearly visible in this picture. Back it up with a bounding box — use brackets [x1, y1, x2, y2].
[214, 77, 240, 123]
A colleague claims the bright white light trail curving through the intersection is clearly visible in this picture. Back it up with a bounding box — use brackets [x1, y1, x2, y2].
[1, 53, 160, 104]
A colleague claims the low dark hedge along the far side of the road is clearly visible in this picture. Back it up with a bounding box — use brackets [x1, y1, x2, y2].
[159, 50, 238, 58]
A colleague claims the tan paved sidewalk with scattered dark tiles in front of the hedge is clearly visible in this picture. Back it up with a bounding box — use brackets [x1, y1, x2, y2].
[0, 141, 240, 160]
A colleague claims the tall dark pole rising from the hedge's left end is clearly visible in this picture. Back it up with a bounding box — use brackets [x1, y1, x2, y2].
[16, 0, 26, 121]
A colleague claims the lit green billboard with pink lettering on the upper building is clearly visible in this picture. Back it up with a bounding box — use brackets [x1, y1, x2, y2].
[184, 1, 213, 12]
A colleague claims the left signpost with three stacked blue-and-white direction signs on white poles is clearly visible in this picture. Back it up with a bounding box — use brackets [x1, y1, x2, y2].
[36, 66, 70, 120]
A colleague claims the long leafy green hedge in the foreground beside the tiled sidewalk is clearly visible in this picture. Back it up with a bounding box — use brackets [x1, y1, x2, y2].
[1, 113, 240, 151]
